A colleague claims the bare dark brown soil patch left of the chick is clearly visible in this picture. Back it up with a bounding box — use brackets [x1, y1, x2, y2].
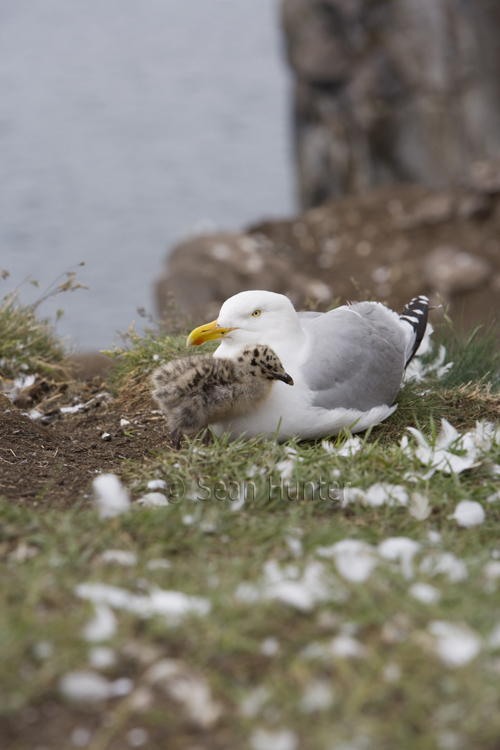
[0, 379, 170, 508]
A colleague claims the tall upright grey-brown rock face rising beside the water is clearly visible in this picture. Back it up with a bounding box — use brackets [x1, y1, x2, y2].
[282, 0, 500, 208]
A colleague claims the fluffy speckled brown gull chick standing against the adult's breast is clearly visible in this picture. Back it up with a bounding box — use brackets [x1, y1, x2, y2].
[152, 344, 293, 449]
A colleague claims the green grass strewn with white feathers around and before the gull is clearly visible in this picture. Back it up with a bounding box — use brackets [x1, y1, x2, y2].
[0, 302, 500, 750]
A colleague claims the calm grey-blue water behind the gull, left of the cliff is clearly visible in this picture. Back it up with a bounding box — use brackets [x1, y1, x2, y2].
[0, 0, 293, 349]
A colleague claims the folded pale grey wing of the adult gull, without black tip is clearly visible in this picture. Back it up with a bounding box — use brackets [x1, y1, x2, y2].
[301, 302, 406, 411]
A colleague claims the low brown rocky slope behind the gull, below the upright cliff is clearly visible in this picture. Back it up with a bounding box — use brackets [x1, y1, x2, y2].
[156, 163, 500, 327]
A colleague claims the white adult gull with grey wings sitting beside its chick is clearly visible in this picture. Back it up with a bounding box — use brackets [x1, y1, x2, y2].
[187, 291, 429, 441]
